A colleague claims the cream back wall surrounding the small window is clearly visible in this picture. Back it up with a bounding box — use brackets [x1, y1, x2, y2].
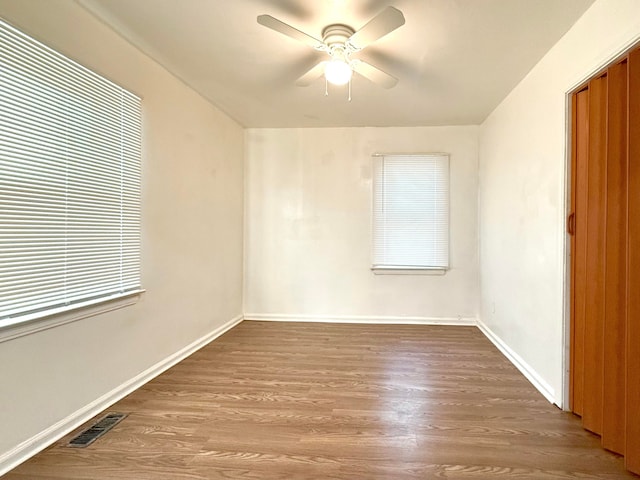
[245, 127, 479, 321]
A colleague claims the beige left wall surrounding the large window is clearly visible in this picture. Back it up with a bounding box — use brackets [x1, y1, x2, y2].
[0, 0, 244, 466]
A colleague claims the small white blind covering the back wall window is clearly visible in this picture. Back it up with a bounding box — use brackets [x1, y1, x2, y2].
[372, 154, 449, 270]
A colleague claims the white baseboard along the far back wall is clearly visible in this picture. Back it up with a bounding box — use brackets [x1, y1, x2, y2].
[244, 313, 477, 326]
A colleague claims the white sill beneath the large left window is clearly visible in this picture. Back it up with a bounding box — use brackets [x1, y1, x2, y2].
[0, 289, 144, 343]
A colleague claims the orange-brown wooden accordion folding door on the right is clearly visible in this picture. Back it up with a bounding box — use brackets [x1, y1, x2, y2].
[568, 45, 640, 473]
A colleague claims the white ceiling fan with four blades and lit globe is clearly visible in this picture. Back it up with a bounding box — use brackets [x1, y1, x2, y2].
[258, 7, 405, 93]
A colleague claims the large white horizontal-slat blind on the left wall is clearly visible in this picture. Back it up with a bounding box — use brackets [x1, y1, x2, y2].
[0, 21, 141, 327]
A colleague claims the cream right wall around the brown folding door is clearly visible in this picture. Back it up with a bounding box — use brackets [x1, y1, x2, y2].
[479, 0, 640, 404]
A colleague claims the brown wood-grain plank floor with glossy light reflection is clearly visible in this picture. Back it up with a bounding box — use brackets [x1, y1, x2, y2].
[4, 322, 638, 480]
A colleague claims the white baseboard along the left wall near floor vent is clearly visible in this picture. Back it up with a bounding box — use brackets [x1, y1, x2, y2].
[0, 315, 243, 477]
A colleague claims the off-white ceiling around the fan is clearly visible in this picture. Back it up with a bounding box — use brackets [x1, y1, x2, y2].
[80, 0, 593, 127]
